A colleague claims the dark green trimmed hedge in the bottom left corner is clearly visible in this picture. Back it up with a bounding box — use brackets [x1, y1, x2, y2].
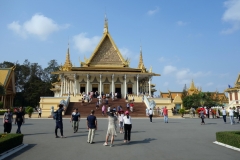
[0, 133, 23, 153]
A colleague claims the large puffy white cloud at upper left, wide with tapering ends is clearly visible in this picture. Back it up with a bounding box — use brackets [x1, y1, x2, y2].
[8, 14, 69, 40]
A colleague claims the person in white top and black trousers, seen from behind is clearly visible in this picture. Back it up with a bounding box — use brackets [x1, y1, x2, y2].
[123, 111, 132, 143]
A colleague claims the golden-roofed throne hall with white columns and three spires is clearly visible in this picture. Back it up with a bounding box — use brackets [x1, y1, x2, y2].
[51, 18, 160, 98]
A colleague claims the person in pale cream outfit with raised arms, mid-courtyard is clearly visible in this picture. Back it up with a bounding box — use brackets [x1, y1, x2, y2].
[103, 109, 117, 147]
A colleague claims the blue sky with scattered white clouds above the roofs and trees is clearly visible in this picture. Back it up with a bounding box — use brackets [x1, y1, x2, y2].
[0, 0, 240, 94]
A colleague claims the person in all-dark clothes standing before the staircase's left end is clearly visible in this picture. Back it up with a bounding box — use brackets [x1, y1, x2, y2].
[54, 104, 66, 138]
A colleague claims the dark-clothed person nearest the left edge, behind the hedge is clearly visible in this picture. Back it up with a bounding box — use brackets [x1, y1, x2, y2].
[3, 108, 13, 133]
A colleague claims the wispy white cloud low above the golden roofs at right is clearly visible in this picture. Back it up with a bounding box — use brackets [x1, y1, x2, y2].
[163, 65, 211, 84]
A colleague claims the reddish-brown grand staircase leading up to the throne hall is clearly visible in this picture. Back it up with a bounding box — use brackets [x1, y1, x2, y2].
[64, 98, 146, 118]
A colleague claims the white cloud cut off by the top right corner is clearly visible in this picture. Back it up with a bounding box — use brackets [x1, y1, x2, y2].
[222, 0, 240, 34]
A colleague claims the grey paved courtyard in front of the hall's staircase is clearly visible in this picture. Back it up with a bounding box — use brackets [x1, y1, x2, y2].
[0, 118, 240, 160]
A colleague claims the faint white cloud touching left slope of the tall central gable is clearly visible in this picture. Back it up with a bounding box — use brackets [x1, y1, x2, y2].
[73, 33, 101, 53]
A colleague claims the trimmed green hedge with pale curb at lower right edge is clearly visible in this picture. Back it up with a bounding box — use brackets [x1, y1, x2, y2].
[216, 131, 240, 148]
